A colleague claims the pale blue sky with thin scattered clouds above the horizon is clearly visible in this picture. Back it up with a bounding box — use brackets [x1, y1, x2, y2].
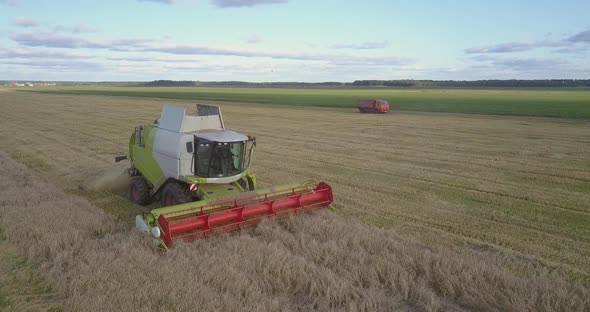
[0, 0, 590, 82]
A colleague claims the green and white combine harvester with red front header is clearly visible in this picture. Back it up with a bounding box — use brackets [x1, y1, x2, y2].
[115, 104, 333, 247]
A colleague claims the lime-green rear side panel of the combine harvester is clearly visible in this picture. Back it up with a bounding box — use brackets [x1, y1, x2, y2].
[129, 126, 166, 187]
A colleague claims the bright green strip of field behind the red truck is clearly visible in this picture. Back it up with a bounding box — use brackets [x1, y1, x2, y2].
[21, 87, 590, 119]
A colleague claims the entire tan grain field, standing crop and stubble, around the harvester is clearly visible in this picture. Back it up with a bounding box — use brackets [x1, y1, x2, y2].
[0, 92, 590, 311]
